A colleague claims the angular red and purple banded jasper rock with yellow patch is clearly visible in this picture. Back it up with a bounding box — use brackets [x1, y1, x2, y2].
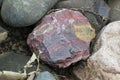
[27, 9, 95, 68]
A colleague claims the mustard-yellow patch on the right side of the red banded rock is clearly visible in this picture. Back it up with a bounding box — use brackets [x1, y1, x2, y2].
[74, 23, 95, 42]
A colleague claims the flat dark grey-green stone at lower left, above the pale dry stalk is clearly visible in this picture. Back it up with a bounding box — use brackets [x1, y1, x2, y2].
[0, 51, 30, 71]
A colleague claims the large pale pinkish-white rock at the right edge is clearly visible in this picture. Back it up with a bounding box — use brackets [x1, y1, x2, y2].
[73, 21, 120, 80]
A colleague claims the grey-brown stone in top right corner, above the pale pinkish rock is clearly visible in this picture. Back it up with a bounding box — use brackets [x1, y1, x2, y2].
[108, 0, 120, 21]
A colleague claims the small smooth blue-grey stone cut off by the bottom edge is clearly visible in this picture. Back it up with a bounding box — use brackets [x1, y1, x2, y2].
[35, 71, 56, 80]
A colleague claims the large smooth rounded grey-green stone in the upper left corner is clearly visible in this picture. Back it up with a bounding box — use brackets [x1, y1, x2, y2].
[1, 0, 58, 27]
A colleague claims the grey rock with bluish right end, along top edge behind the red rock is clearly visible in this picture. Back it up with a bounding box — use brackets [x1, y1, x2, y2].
[56, 0, 110, 19]
